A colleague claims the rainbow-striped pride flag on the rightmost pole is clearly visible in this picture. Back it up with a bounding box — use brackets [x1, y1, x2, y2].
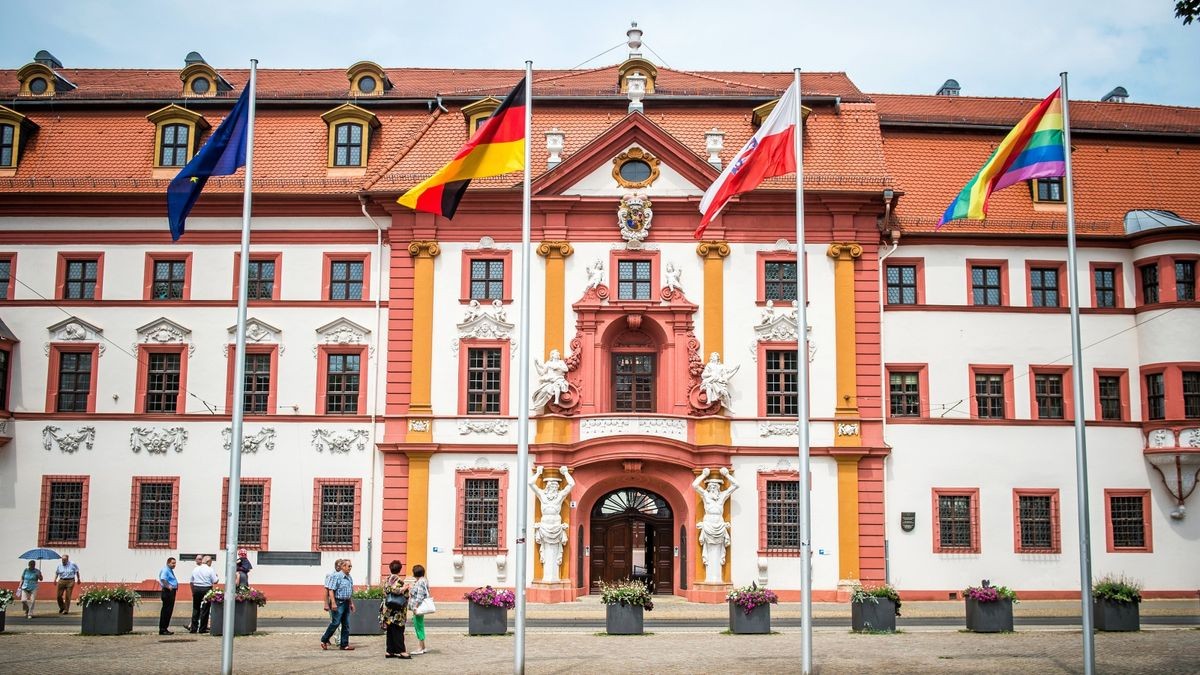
[937, 89, 1067, 227]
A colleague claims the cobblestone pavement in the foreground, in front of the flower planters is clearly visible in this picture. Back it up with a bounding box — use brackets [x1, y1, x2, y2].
[0, 627, 1200, 675]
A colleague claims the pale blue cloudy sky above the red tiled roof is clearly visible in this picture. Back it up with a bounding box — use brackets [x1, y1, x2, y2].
[0, 0, 1200, 107]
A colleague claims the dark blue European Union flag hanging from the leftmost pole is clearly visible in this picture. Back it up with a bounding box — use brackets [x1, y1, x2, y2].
[167, 85, 250, 241]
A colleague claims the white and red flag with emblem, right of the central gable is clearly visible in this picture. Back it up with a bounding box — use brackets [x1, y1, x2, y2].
[694, 83, 799, 239]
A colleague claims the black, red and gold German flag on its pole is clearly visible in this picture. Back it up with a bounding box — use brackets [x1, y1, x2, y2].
[397, 78, 526, 219]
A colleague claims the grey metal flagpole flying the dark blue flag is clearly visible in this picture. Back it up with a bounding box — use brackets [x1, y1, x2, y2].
[221, 59, 258, 675]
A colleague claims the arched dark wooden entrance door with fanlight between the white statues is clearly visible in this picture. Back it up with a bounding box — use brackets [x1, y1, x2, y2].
[589, 488, 674, 593]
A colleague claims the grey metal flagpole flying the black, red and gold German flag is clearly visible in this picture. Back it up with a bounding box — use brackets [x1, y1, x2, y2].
[512, 61, 533, 675]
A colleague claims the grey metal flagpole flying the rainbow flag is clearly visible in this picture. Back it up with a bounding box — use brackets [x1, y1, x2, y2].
[1058, 72, 1096, 675]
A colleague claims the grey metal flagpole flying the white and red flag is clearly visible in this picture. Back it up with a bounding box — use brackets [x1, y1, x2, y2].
[792, 68, 812, 675]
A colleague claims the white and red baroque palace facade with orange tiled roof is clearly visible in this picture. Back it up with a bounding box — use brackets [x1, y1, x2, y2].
[0, 41, 1200, 601]
